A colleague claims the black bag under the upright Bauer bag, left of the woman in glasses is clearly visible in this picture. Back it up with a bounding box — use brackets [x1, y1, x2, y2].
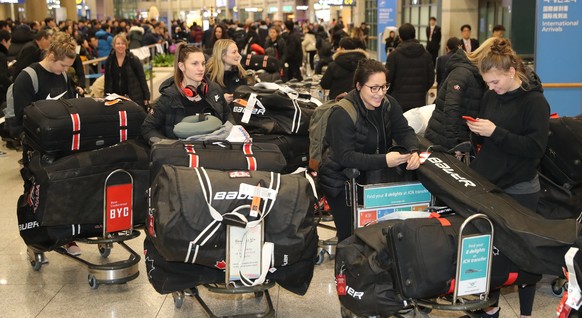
[251, 134, 309, 173]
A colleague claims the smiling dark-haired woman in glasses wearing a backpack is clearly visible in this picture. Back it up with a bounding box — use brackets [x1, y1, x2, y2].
[319, 59, 420, 241]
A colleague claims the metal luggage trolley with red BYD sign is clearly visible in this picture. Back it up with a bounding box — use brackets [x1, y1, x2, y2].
[27, 169, 141, 289]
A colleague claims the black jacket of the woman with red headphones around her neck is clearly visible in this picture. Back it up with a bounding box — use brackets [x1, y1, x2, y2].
[141, 77, 235, 142]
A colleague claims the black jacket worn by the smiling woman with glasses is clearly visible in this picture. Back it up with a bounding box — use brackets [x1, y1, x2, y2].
[319, 89, 418, 196]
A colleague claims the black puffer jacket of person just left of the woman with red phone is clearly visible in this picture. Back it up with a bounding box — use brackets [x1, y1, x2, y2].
[424, 50, 485, 149]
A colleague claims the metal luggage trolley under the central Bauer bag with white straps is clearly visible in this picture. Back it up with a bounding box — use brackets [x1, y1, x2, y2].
[172, 214, 275, 318]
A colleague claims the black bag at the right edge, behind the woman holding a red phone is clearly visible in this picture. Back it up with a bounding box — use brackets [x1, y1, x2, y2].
[540, 115, 582, 188]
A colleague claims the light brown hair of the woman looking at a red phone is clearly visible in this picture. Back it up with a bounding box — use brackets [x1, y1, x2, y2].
[478, 37, 528, 84]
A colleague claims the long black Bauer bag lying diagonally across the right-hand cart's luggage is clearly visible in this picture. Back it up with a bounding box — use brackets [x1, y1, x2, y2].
[417, 152, 578, 276]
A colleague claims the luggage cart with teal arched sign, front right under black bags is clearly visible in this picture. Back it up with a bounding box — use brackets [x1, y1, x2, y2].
[341, 168, 497, 318]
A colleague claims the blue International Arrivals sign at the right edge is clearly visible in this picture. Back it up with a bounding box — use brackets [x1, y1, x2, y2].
[535, 0, 582, 116]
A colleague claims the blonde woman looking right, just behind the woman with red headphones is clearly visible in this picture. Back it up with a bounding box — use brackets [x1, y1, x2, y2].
[206, 39, 246, 104]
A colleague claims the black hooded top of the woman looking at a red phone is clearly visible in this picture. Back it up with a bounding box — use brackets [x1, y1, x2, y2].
[471, 71, 550, 189]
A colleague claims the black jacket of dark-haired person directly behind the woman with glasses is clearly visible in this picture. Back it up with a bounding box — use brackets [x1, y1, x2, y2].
[320, 49, 368, 99]
